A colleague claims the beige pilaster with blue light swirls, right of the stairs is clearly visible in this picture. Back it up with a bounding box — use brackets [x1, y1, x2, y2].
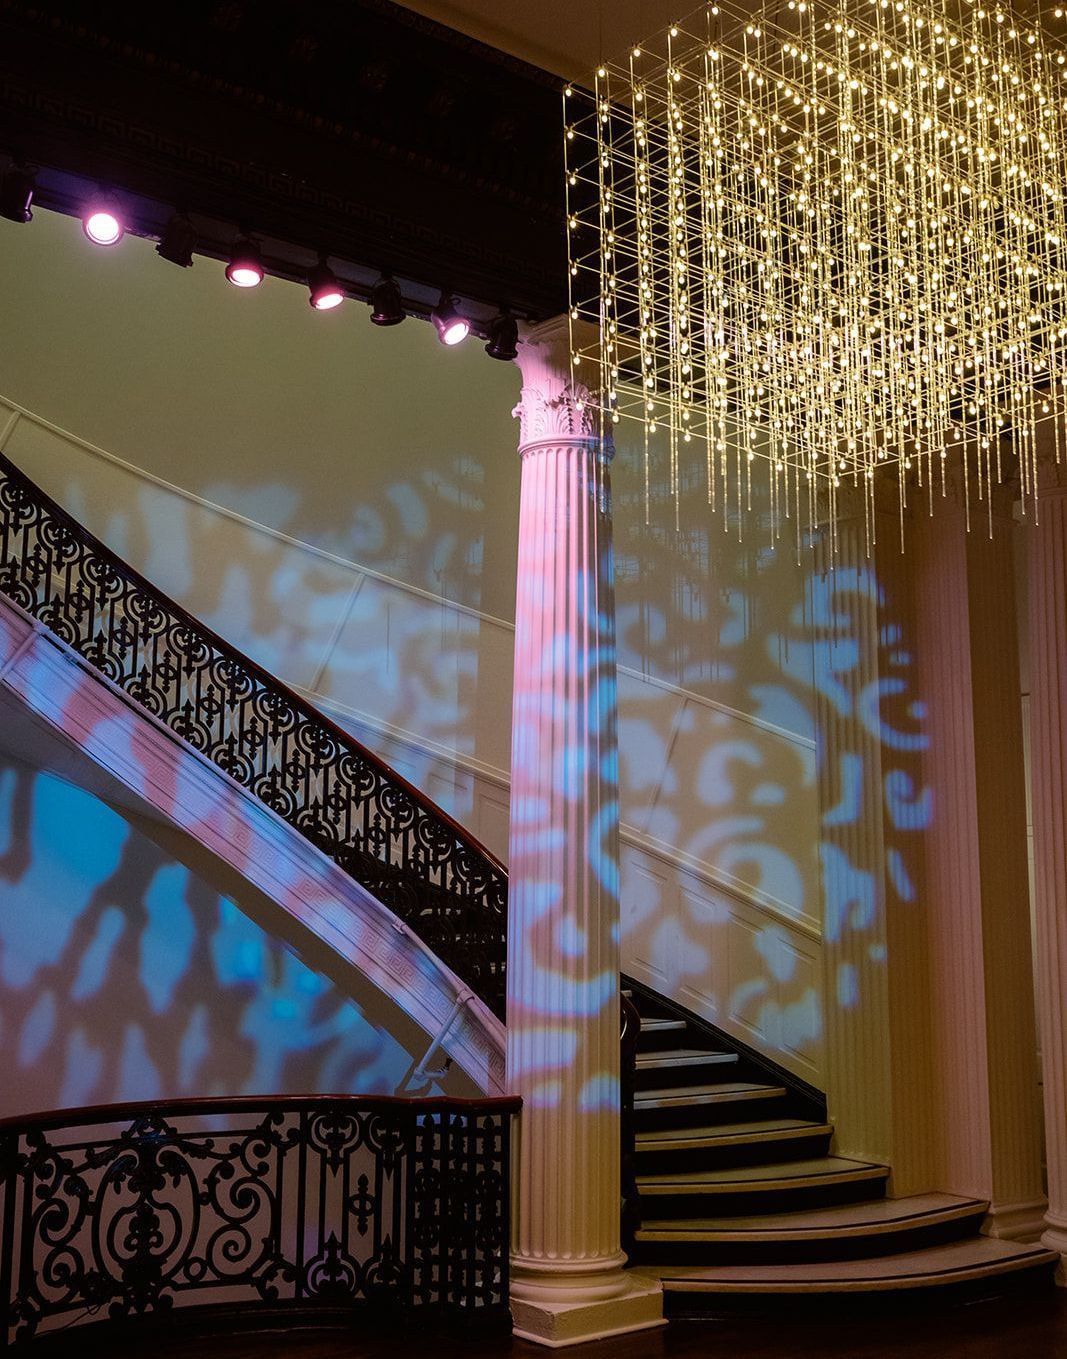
[809, 488, 932, 1195]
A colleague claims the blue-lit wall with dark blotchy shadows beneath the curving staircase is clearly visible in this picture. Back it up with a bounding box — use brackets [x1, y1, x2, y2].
[0, 757, 448, 1116]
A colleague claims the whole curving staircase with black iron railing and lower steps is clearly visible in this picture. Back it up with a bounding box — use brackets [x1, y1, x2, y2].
[0, 455, 1059, 1317]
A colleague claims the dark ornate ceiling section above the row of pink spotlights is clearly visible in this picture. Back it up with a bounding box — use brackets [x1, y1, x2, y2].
[0, 0, 567, 317]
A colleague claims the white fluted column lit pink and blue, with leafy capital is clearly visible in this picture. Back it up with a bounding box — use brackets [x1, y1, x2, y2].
[507, 321, 662, 1345]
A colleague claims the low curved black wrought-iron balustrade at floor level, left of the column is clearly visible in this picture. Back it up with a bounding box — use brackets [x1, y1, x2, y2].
[0, 1095, 519, 1349]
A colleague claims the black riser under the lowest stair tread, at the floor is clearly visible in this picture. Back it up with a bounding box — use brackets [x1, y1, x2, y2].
[663, 1264, 1055, 1321]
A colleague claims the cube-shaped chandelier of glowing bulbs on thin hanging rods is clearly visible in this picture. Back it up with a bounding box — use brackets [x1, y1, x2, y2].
[564, 0, 1067, 545]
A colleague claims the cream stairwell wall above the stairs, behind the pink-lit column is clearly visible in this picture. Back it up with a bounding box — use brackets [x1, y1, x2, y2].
[0, 213, 821, 1080]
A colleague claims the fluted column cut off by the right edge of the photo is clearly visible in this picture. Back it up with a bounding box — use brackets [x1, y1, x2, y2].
[1029, 451, 1067, 1282]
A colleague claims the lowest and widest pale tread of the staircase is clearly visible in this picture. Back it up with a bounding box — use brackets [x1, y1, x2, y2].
[635, 1237, 1059, 1294]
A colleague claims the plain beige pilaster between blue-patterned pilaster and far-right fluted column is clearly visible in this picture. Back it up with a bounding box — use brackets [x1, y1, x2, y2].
[908, 477, 1045, 1238]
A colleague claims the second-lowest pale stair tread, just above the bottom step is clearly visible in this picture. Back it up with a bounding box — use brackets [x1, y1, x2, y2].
[637, 1193, 990, 1241]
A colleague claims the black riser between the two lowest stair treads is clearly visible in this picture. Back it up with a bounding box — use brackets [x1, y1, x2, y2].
[632, 1214, 983, 1265]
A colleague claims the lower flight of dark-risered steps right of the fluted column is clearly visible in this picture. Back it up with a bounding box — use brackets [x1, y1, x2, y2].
[627, 987, 1059, 1317]
